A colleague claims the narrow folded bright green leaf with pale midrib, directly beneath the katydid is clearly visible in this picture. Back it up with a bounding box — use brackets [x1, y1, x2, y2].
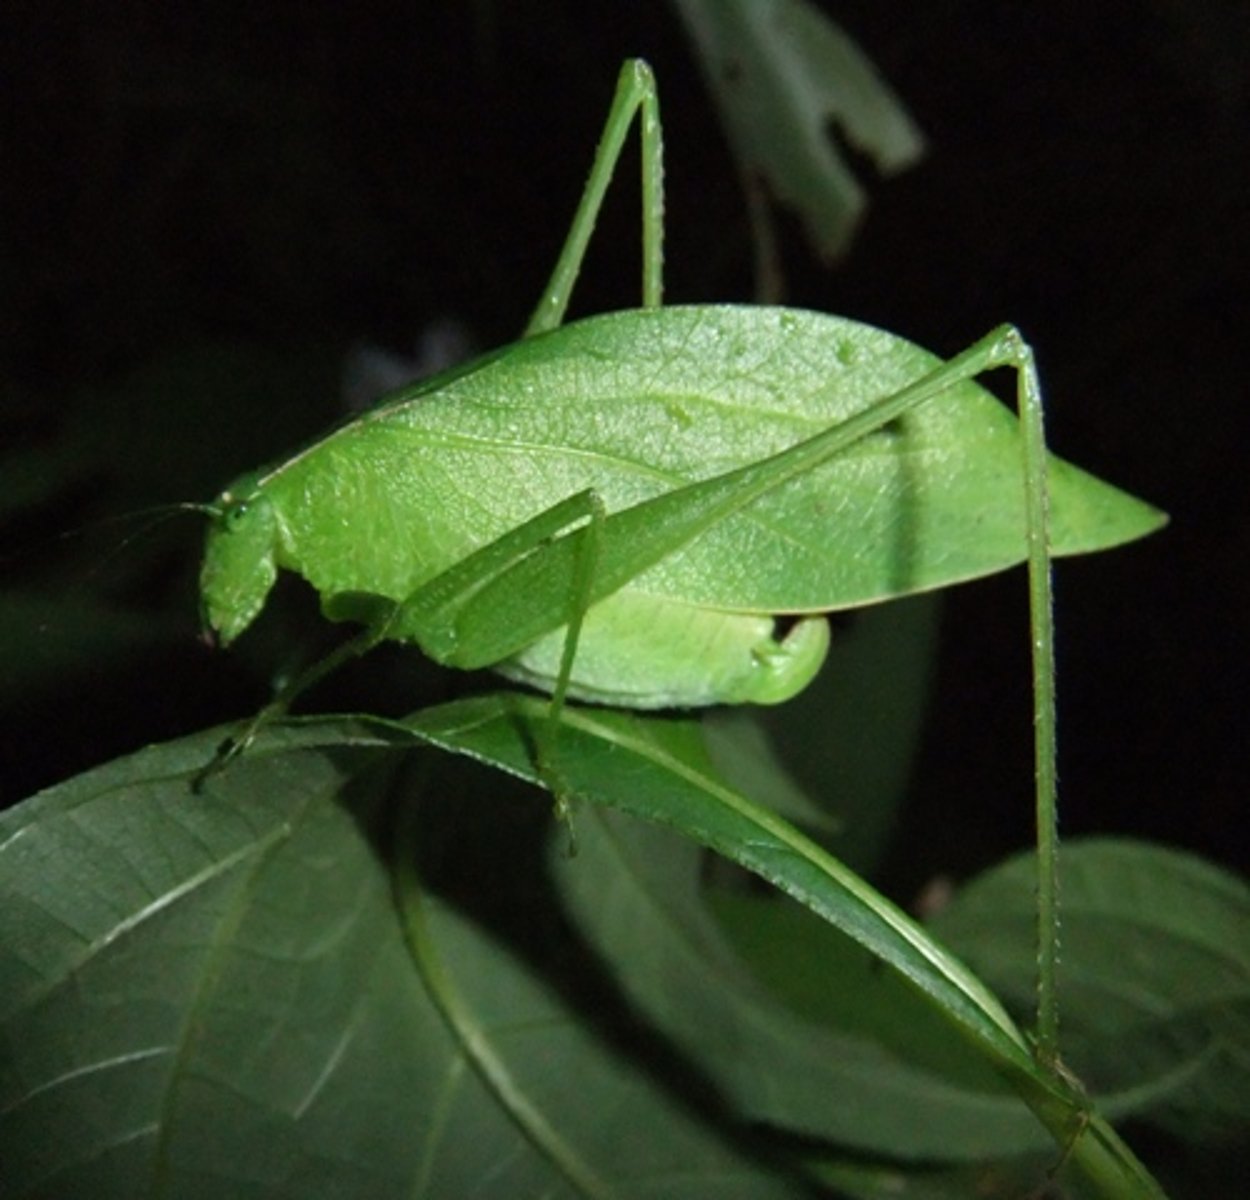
[410, 694, 1161, 1196]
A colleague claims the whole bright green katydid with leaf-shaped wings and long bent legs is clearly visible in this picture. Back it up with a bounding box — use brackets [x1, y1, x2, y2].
[201, 61, 1163, 1050]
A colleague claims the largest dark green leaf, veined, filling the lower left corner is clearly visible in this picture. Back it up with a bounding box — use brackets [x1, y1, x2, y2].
[0, 721, 793, 1200]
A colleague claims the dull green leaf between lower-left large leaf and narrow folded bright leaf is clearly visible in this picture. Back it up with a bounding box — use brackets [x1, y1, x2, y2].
[559, 810, 1049, 1161]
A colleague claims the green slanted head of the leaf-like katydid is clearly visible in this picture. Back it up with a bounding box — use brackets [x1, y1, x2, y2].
[200, 475, 278, 645]
